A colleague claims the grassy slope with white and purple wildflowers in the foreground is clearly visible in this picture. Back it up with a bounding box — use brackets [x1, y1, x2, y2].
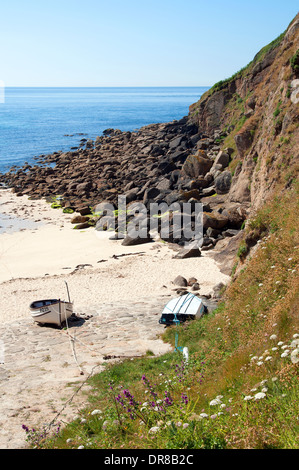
[24, 185, 299, 449]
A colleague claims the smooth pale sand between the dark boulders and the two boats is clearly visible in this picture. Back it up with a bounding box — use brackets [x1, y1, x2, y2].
[0, 189, 229, 322]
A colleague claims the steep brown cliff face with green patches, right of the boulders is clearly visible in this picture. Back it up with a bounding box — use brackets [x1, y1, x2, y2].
[188, 14, 299, 211]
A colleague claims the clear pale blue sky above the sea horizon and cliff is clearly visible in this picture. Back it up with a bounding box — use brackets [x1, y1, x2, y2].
[0, 0, 299, 87]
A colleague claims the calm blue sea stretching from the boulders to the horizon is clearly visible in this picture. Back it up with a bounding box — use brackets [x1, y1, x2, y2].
[0, 87, 208, 172]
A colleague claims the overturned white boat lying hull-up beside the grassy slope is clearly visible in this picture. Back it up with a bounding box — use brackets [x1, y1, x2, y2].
[159, 293, 207, 326]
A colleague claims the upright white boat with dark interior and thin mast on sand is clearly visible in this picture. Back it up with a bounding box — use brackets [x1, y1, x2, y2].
[30, 299, 73, 326]
